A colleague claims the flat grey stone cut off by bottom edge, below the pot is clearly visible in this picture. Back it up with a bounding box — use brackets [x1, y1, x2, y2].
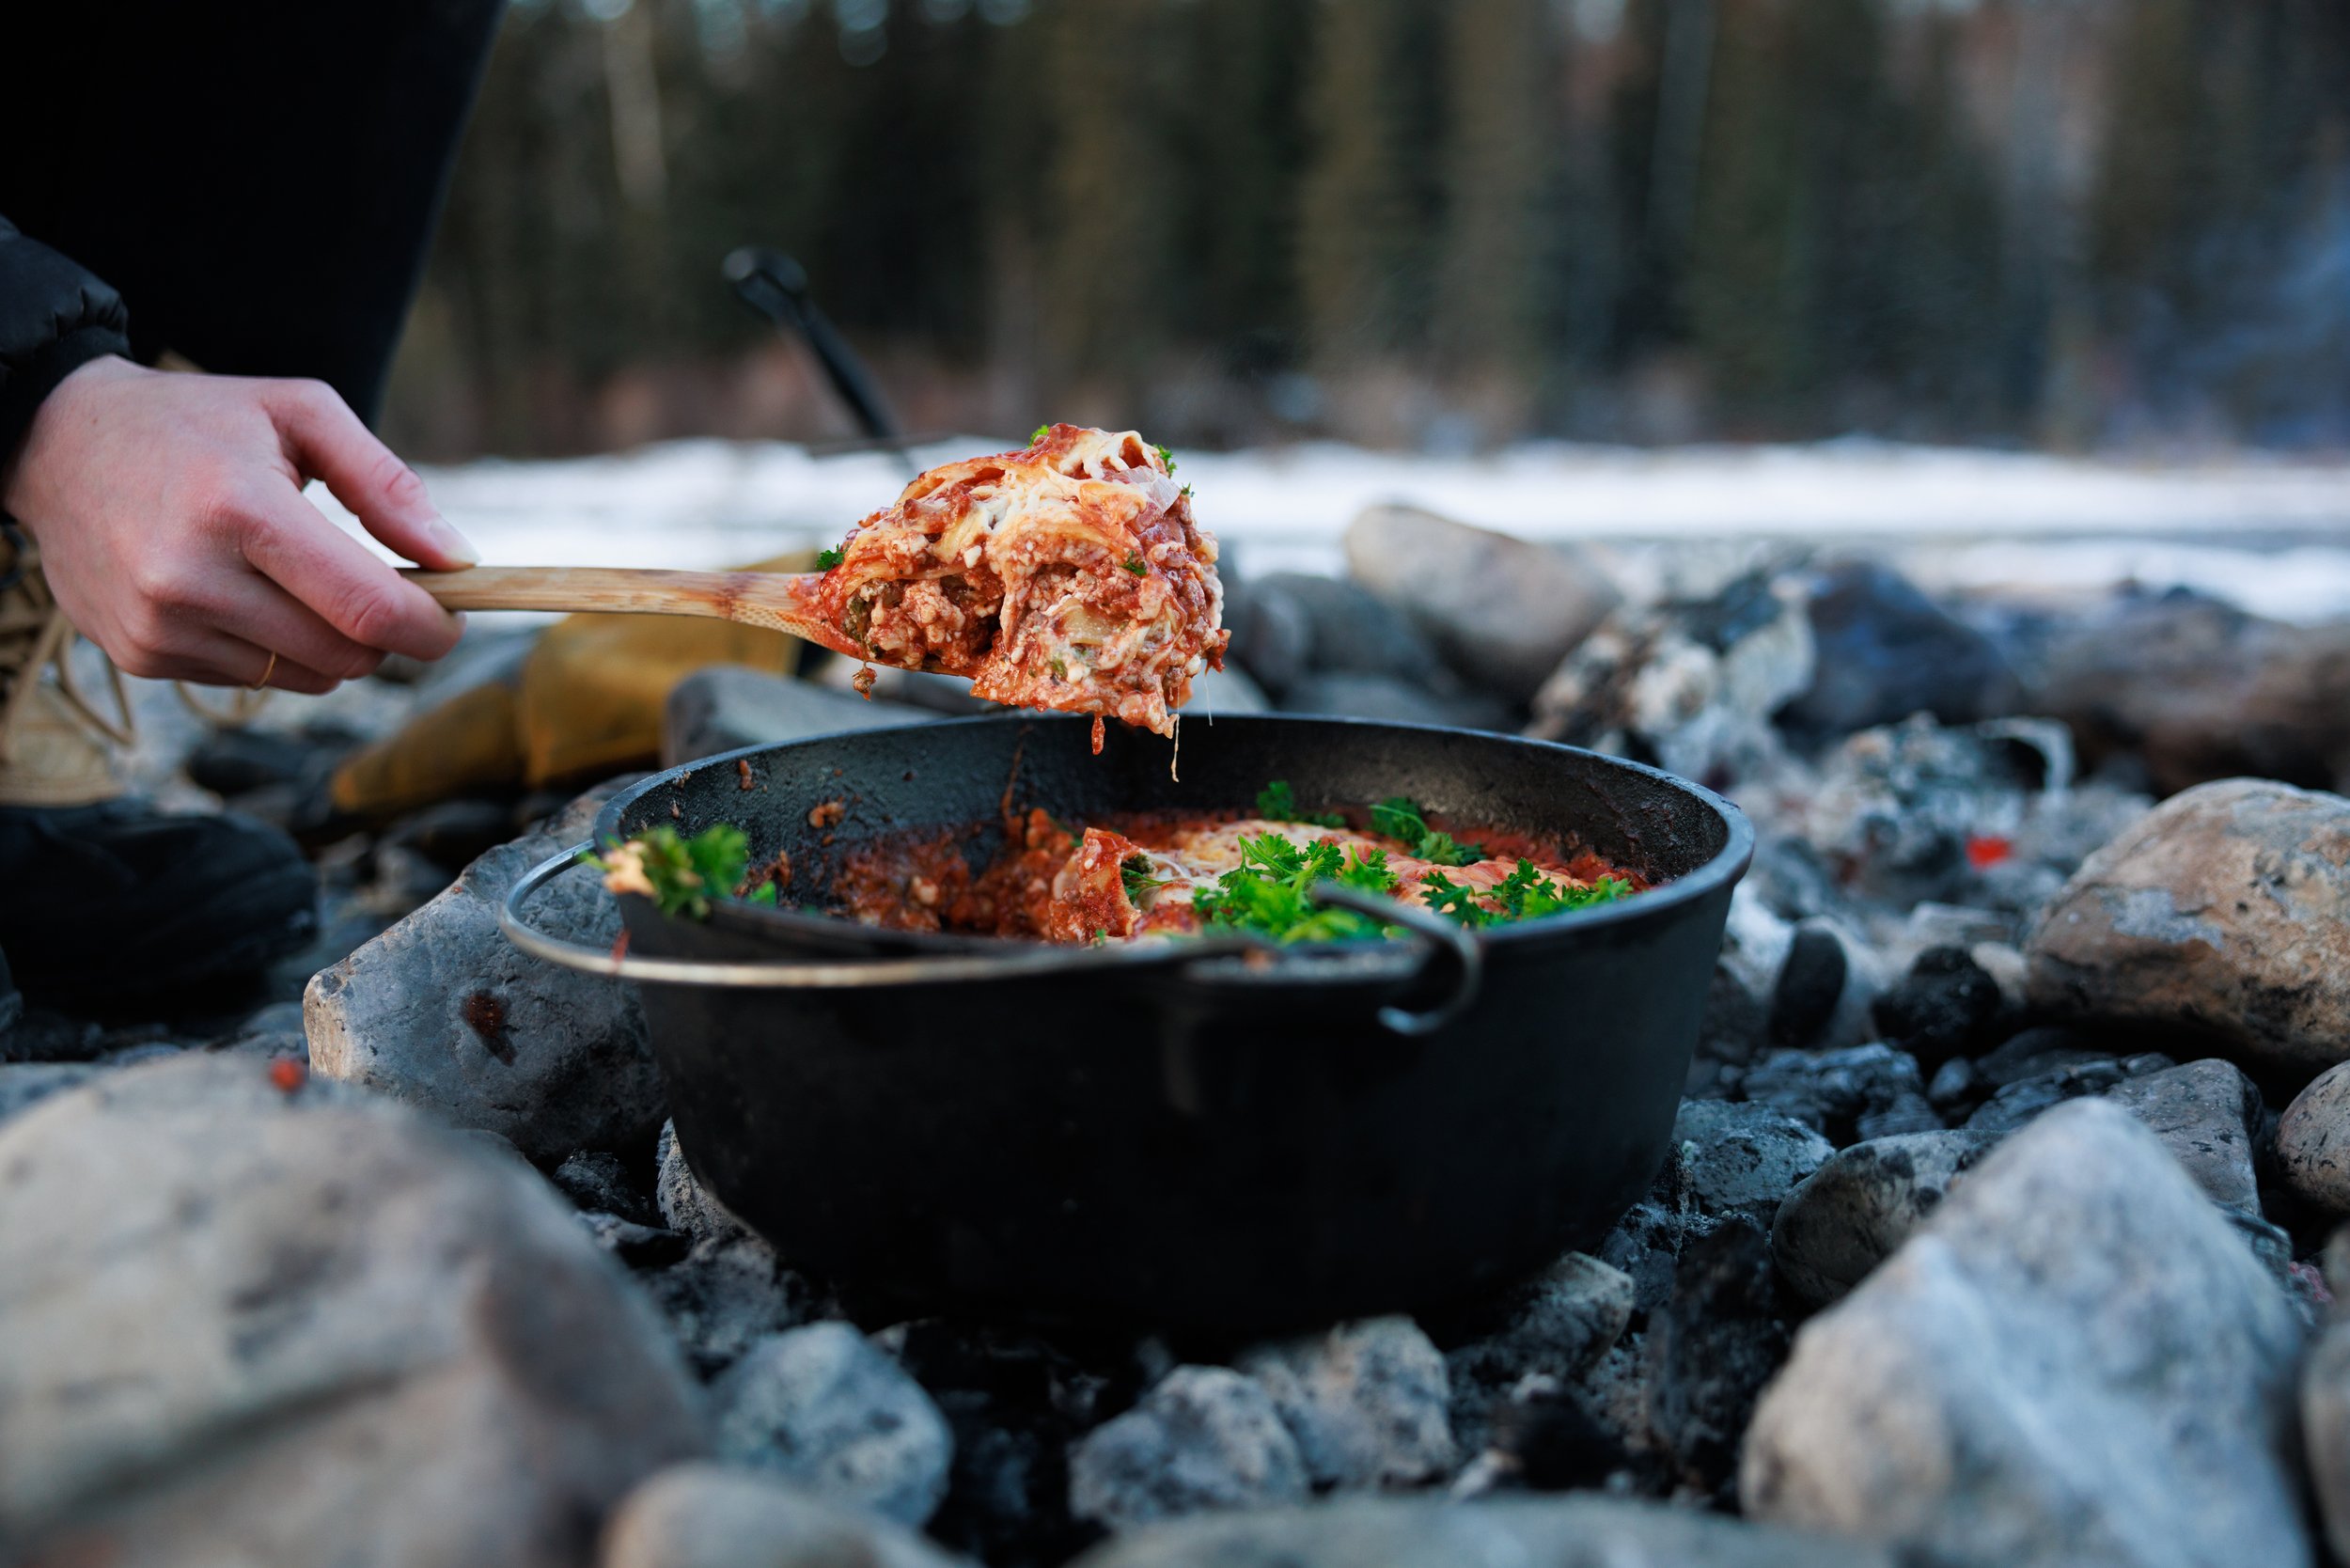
[1072, 1495, 1892, 1568]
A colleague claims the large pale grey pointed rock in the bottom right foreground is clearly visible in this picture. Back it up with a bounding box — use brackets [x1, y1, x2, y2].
[1739, 1100, 2311, 1568]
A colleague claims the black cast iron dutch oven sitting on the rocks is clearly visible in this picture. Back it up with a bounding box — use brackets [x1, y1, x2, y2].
[508, 714, 1753, 1333]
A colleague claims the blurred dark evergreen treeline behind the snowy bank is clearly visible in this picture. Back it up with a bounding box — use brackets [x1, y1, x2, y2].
[390, 0, 2350, 459]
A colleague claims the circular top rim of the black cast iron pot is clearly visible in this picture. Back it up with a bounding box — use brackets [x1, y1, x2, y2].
[595, 713, 1756, 964]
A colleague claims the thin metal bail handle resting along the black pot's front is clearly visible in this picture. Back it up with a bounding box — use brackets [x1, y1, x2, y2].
[498, 839, 1483, 1034]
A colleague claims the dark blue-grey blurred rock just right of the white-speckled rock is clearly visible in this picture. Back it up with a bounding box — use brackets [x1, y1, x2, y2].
[1779, 562, 2021, 736]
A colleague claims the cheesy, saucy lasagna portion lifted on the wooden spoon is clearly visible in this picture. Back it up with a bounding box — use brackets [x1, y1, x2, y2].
[816, 426, 1231, 745]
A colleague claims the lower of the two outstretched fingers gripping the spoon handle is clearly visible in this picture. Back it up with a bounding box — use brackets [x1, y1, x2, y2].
[238, 484, 465, 661]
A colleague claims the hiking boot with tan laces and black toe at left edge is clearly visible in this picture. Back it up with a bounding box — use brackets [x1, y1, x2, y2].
[0, 525, 318, 1013]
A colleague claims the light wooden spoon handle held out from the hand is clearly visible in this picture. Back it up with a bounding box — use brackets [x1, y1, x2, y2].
[400, 567, 865, 663]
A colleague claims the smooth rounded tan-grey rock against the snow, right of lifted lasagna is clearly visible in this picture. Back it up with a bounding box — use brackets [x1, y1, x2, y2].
[1347, 506, 1617, 703]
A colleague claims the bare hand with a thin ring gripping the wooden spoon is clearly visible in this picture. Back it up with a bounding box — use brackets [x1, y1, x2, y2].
[0, 357, 478, 694]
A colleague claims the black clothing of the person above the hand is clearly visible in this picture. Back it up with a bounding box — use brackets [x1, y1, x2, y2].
[0, 0, 503, 463]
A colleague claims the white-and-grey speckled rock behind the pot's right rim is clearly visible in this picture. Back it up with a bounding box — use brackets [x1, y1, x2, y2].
[1526, 573, 1812, 783]
